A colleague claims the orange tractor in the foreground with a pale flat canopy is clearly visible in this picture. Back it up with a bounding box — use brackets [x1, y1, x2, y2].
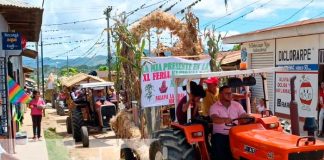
[149, 67, 324, 160]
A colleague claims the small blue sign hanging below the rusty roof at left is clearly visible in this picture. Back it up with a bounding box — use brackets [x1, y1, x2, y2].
[2, 32, 21, 50]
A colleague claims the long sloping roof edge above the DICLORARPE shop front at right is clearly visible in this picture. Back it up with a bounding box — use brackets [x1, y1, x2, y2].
[223, 17, 324, 44]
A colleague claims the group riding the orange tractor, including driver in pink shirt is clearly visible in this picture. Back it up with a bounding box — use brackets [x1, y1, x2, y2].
[176, 77, 253, 159]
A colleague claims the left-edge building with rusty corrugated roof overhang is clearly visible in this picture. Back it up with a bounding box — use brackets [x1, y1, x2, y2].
[0, 0, 43, 153]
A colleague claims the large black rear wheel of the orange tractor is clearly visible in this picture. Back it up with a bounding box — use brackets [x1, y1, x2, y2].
[150, 129, 197, 160]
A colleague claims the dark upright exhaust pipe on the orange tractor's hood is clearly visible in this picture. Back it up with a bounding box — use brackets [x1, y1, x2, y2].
[289, 76, 300, 136]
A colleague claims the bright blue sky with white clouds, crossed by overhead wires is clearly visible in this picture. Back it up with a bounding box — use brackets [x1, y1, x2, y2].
[24, 0, 324, 62]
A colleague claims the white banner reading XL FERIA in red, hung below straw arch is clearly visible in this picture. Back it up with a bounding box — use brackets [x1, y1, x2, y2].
[141, 57, 210, 107]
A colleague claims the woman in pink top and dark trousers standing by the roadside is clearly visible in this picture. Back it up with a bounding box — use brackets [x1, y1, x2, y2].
[29, 90, 45, 140]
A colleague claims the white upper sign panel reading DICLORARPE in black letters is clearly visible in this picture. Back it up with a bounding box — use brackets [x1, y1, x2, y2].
[276, 35, 319, 65]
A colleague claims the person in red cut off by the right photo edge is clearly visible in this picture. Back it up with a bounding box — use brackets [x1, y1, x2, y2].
[318, 82, 324, 137]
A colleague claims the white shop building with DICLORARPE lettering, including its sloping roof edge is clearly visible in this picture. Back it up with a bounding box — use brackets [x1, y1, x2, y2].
[223, 18, 324, 118]
